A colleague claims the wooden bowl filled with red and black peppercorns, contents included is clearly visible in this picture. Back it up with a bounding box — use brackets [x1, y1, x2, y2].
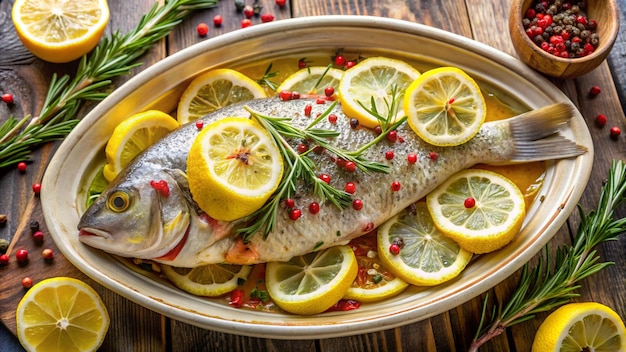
[509, 0, 619, 78]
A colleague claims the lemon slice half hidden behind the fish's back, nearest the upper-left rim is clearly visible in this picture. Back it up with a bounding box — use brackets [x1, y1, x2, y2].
[177, 68, 267, 125]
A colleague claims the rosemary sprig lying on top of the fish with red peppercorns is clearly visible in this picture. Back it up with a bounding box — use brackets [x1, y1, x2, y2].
[238, 93, 406, 241]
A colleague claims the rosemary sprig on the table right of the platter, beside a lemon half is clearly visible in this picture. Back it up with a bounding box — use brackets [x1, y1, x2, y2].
[469, 161, 626, 351]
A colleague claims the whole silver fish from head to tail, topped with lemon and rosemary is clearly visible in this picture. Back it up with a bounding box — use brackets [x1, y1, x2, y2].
[78, 98, 586, 267]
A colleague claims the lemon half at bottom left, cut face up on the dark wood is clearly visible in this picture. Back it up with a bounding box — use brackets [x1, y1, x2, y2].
[16, 277, 109, 351]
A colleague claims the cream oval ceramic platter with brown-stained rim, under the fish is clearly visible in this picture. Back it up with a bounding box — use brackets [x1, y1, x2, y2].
[41, 16, 593, 339]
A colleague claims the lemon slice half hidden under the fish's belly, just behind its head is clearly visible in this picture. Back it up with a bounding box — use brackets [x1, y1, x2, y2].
[161, 264, 252, 297]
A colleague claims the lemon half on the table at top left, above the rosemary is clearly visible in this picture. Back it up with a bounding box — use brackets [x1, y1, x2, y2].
[12, 0, 109, 63]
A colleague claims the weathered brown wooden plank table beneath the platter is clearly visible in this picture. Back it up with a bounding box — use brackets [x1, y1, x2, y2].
[0, 0, 626, 351]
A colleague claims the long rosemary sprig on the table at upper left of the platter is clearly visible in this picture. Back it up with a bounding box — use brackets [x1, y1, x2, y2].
[0, 0, 218, 168]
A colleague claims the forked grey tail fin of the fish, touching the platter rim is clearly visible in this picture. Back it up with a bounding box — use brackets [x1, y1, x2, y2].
[509, 103, 587, 162]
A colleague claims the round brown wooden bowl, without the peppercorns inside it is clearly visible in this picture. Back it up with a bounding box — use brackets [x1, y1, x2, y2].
[509, 0, 619, 78]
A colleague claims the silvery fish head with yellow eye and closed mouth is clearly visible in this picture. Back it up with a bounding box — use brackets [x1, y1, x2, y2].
[78, 166, 190, 259]
